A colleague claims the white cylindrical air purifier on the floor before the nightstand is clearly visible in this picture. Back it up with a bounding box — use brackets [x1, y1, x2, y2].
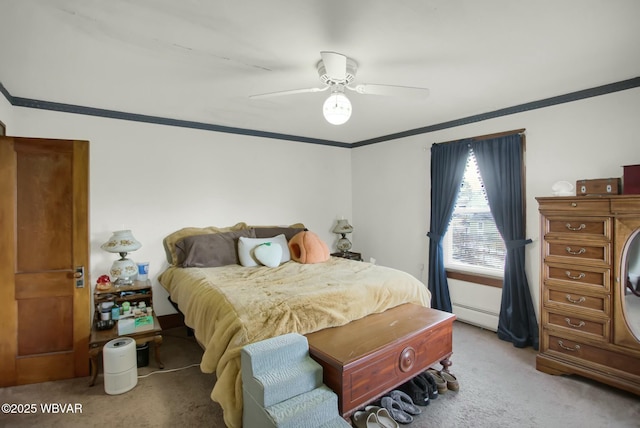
[102, 337, 138, 395]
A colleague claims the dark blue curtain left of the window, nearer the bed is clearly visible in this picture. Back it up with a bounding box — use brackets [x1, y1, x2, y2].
[427, 141, 469, 312]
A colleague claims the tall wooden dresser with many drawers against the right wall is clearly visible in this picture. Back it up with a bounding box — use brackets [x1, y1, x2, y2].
[536, 195, 640, 394]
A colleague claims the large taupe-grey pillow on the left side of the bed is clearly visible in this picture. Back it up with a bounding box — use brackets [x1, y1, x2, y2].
[175, 229, 255, 267]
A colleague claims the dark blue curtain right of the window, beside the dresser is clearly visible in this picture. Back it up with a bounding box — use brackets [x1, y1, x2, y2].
[473, 134, 539, 349]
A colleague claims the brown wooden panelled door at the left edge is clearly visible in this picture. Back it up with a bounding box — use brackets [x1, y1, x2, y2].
[0, 137, 91, 386]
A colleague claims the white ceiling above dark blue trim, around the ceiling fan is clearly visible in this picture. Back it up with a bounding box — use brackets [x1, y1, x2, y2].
[0, 0, 640, 143]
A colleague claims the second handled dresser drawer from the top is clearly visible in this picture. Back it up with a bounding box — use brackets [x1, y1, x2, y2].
[544, 240, 611, 267]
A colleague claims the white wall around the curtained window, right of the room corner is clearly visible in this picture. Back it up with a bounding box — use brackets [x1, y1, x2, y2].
[352, 88, 640, 326]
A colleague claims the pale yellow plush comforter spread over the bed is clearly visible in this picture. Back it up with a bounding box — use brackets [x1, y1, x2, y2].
[159, 257, 431, 428]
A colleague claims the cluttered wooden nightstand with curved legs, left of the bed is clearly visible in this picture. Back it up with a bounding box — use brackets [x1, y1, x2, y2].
[89, 280, 164, 386]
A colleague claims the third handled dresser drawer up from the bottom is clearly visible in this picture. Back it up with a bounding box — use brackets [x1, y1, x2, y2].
[543, 287, 611, 317]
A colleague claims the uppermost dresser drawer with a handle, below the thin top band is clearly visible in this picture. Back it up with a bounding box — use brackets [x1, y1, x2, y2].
[544, 216, 612, 241]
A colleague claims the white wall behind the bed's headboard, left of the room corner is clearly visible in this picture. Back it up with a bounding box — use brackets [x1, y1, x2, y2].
[7, 107, 351, 315]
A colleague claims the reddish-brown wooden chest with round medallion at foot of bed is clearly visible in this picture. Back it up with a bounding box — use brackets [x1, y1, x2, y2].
[307, 303, 455, 418]
